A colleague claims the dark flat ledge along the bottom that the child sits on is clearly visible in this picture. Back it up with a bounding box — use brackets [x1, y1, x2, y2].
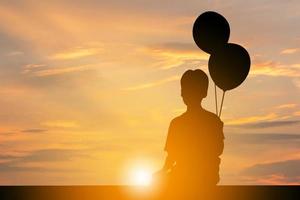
[0, 186, 300, 200]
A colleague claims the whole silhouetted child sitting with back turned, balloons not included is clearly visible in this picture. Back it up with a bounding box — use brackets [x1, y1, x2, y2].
[156, 69, 224, 196]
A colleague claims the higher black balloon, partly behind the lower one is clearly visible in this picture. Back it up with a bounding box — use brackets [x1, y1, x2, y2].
[193, 11, 230, 54]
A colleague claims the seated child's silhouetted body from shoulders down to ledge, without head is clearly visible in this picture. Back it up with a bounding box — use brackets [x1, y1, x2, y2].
[165, 108, 224, 185]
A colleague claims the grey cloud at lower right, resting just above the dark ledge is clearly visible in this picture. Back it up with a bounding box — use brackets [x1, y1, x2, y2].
[241, 160, 300, 185]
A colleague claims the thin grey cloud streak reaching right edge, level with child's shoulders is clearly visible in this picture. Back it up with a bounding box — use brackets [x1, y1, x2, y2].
[233, 120, 300, 128]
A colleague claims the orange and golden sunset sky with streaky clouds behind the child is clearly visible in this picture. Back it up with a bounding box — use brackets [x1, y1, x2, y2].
[0, 0, 300, 185]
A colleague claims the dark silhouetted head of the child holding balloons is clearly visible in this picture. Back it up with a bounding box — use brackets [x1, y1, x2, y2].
[180, 69, 208, 106]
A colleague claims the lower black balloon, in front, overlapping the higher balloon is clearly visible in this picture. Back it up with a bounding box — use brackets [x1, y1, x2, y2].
[208, 43, 251, 91]
